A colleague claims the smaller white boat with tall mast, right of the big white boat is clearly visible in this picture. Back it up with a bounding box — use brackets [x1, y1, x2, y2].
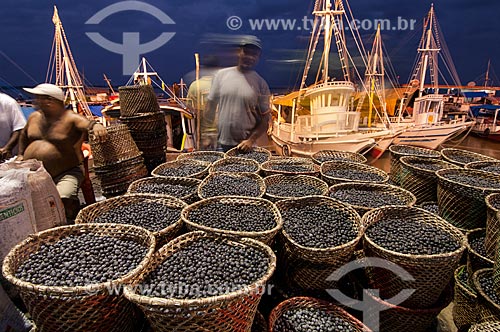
[391, 5, 473, 150]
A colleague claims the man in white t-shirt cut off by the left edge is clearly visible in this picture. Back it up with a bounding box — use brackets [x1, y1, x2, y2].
[0, 93, 26, 161]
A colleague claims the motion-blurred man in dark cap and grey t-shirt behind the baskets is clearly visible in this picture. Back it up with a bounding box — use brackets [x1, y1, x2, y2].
[206, 36, 270, 151]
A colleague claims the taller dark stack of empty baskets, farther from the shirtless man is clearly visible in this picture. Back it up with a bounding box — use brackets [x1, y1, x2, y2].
[119, 85, 167, 172]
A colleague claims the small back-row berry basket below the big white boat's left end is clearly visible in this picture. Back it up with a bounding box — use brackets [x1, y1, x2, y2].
[261, 157, 320, 176]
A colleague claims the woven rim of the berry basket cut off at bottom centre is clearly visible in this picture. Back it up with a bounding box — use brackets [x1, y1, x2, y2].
[269, 296, 371, 332]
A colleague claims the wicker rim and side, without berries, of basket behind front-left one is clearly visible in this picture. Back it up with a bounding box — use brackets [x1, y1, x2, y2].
[75, 194, 187, 247]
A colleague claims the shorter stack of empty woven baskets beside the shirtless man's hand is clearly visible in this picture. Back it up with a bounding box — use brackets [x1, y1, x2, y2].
[89, 124, 147, 197]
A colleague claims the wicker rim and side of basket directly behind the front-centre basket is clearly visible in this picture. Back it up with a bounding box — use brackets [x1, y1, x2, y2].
[181, 196, 283, 244]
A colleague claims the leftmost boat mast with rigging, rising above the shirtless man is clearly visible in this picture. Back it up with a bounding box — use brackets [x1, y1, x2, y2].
[49, 6, 92, 118]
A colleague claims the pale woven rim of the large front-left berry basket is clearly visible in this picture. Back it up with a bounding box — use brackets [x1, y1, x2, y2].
[2, 223, 156, 296]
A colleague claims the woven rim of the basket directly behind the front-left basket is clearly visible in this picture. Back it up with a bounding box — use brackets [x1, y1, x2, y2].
[75, 193, 188, 237]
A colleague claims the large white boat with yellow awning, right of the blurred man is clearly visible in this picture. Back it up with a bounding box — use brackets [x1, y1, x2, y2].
[271, 0, 399, 157]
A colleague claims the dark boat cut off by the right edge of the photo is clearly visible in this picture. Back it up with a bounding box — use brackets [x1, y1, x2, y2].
[470, 104, 500, 141]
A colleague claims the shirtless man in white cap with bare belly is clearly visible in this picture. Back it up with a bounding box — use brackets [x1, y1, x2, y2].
[17, 83, 107, 220]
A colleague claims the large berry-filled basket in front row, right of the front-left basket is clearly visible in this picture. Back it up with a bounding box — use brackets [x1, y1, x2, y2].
[124, 232, 276, 332]
